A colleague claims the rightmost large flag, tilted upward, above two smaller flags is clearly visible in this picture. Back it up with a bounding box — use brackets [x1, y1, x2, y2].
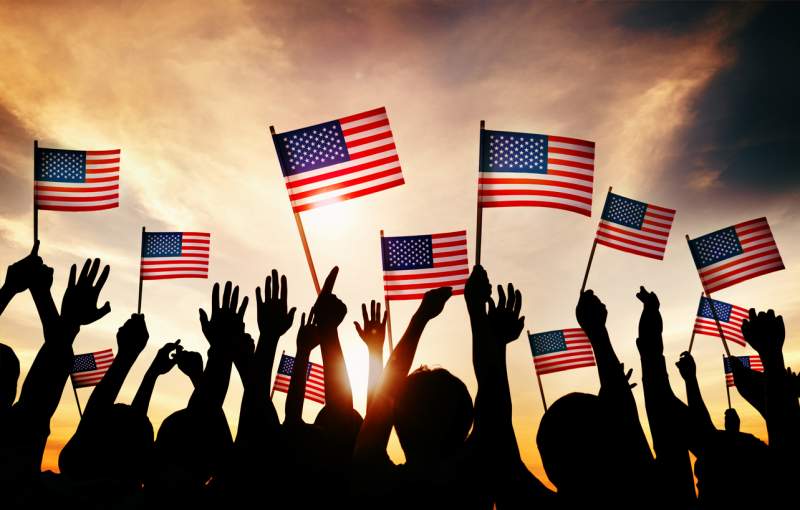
[689, 218, 784, 293]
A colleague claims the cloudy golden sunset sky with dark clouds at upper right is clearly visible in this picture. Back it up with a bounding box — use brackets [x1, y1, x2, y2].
[0, 0, 800, 486]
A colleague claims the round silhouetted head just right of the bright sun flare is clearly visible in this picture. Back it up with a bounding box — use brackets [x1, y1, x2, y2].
[394, 366, 473, 463]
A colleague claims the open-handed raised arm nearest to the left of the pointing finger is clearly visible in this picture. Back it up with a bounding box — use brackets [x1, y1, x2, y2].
[241, 269, 295, 443]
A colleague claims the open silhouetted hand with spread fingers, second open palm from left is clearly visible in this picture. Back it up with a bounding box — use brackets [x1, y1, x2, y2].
[200, 282, 252, 357]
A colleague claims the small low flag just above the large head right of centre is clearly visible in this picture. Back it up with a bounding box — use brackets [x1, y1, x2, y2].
[528, 328, 595, 375]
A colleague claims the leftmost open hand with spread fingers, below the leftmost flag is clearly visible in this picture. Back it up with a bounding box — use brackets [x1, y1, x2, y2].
[61, 259, 111, 327]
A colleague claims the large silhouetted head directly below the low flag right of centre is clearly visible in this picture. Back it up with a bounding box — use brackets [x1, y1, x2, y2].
[536, 393, 623, 498]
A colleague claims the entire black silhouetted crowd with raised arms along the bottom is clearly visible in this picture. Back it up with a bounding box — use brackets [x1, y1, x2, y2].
[0, 244, 800, 509]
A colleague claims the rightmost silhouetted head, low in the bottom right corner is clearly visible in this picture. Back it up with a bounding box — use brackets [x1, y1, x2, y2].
[694, 430, 778, 508]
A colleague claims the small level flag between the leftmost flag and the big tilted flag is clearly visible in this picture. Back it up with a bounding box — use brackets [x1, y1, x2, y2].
[142, 232, 211, 280]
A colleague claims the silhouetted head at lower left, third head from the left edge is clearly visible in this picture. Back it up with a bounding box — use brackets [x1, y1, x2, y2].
[148, 409, 233, 490]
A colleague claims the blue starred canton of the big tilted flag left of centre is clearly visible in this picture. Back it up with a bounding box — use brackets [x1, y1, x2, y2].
[274, 120, 350, 177]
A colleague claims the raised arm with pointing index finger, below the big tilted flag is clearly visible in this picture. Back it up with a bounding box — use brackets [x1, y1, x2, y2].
[314, 267, 353, 414]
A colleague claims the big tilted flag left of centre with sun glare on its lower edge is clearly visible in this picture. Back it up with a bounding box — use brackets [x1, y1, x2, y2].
[272, 108, 404, 212]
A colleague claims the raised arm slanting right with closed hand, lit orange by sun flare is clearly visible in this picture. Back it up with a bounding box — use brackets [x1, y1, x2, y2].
[354, 287, 453, 465]
